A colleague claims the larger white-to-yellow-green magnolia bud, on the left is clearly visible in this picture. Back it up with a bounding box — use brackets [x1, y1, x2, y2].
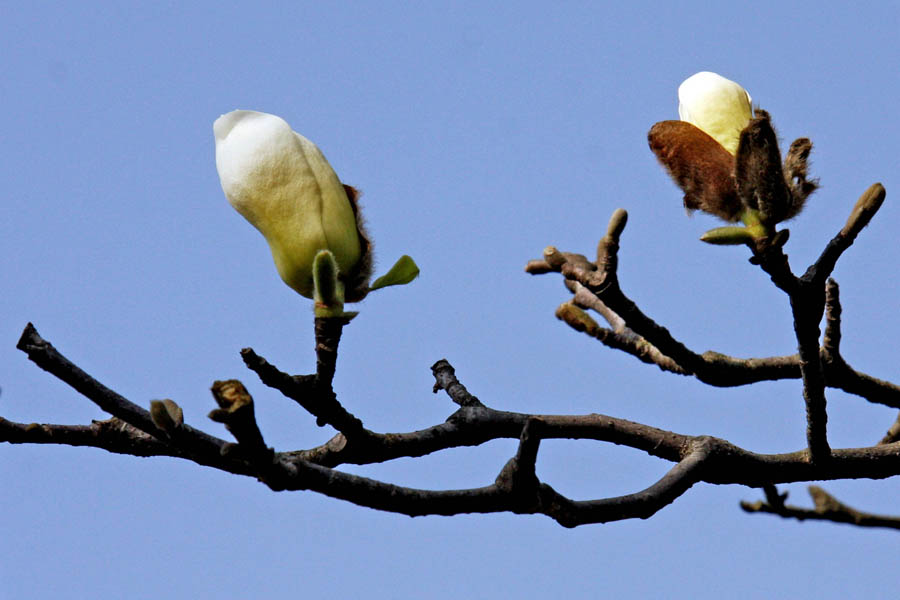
[213, 110, 365, 298]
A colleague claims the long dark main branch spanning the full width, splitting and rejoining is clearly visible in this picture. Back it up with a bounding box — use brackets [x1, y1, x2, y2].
[8, 338, 900, 527]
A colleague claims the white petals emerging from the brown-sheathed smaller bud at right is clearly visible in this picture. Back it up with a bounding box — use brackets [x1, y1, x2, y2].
[678, 71, 752, 154]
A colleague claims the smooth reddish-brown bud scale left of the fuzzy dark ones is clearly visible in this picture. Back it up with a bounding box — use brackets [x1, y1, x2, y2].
[647, 121, 740, 222]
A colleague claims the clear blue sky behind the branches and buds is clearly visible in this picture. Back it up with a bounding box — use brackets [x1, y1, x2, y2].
[0, 2, 900, 598]
